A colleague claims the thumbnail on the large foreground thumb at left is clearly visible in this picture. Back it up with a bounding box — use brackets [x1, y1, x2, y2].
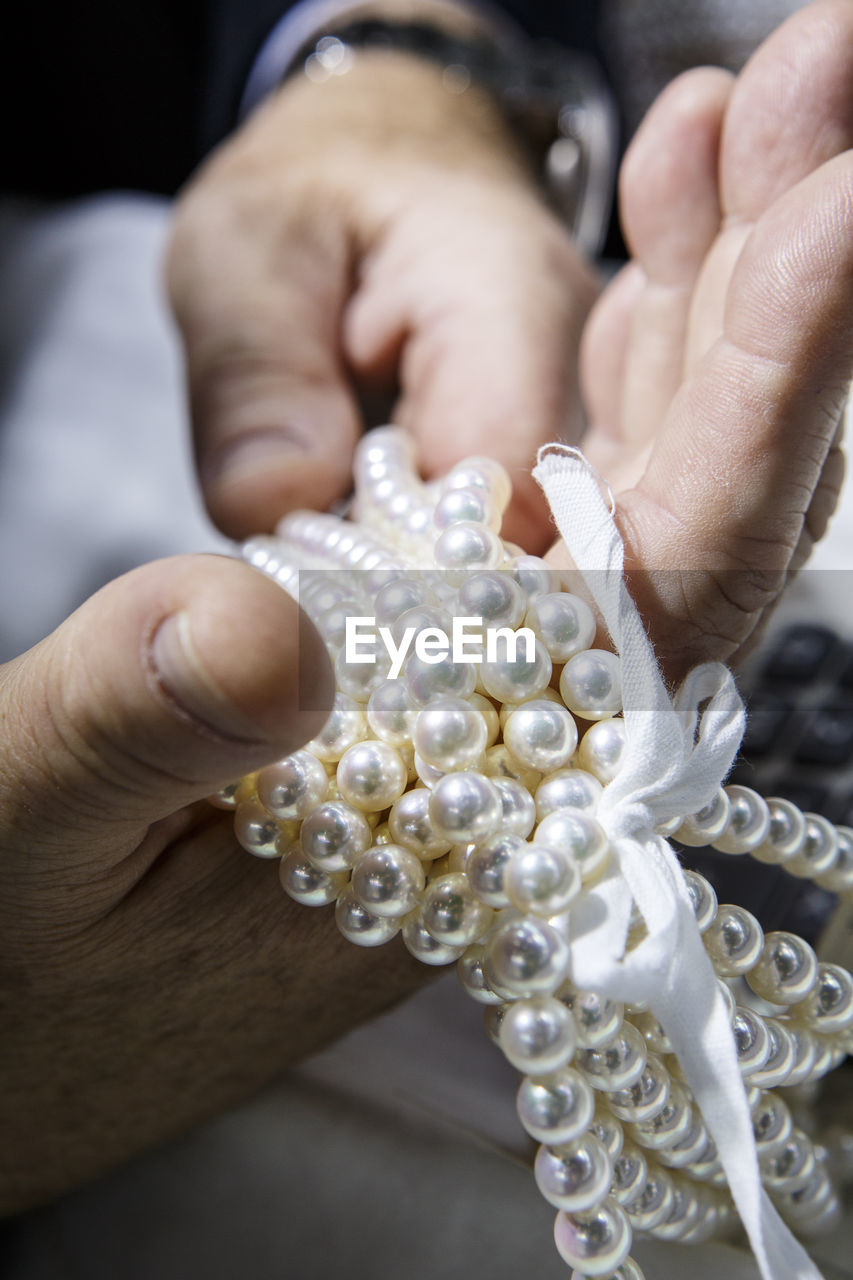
[150, 613, 263, 742]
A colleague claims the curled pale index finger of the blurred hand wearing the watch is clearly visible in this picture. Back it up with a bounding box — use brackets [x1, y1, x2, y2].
[345, 179, 596, 549]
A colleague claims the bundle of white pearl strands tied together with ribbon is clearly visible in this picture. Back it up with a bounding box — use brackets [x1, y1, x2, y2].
[211, 428, 853, 1280]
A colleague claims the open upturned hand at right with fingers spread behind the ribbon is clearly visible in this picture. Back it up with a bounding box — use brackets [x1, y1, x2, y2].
[557, 0, 853, 676]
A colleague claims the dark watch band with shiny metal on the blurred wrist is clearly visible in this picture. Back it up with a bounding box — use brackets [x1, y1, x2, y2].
[249, 13, 617, 257]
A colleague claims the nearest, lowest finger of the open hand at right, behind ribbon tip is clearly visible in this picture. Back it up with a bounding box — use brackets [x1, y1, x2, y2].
[620, 152, 853, 660]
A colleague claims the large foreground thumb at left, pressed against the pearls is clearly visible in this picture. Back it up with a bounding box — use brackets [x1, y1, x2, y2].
[0, 556, 333, 856]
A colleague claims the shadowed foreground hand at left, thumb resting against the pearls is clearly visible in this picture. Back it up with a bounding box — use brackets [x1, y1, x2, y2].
[0, 557, 424, 1216]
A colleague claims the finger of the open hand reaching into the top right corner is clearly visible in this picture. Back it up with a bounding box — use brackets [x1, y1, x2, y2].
[685, 0, 853, 372]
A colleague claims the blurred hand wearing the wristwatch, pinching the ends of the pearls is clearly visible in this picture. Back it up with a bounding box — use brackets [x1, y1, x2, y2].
[168, 51, 596, 549]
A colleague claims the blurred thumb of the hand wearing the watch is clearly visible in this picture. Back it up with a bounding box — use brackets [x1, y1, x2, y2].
[168, 172, 360, 538]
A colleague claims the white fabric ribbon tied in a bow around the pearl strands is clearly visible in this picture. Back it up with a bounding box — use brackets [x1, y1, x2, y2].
[533, 445, 821, 1280]
